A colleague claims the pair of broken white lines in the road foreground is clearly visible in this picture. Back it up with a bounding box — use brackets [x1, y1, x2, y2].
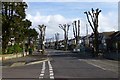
[39, 61, 54, 79]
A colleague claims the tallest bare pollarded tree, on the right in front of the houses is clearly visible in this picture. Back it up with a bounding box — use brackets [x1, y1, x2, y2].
[84, 8, 101, 56]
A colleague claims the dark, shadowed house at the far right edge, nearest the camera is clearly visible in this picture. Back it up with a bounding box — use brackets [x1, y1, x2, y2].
[104, 31, 120, 60]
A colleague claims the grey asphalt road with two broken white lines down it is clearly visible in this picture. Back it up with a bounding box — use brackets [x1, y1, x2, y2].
[2, 50, 118, 80]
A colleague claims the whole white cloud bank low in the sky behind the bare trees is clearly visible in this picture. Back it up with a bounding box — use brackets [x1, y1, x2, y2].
[26, 12, 117, 39]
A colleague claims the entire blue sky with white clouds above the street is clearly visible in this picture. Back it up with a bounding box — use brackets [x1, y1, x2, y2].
[26, 2, 118, 39]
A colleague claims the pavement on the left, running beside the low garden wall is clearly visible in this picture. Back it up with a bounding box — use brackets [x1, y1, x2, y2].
[1, 51, 48, 68]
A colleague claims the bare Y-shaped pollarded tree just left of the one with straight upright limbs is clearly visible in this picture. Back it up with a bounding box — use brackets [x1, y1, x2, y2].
[59, 24, 70, 50]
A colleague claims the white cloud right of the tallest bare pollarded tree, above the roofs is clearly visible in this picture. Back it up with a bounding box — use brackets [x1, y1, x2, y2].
[99, 12, 118, 32]
